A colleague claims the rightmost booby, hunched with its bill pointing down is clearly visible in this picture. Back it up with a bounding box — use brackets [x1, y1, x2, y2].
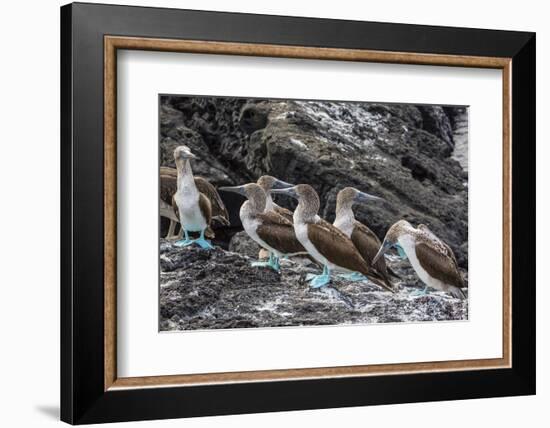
[373, 220, 466, 299]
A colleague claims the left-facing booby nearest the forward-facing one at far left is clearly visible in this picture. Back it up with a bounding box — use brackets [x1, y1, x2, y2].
[220, 183, 306, 271]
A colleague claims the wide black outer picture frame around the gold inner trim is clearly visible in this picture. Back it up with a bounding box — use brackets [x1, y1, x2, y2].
[61, 3, 536, 424]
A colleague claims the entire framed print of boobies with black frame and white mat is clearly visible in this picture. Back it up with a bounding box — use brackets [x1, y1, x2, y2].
[61, 3, 535, 424]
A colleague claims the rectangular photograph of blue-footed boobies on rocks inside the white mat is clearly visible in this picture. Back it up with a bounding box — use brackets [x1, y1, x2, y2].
[158, 94, 470, 332]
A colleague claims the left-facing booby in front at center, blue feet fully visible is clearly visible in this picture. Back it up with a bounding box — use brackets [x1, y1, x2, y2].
[272, 184, 393, 292]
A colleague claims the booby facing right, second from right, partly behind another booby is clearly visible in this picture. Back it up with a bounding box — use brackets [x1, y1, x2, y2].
[333, 187, 393, 289]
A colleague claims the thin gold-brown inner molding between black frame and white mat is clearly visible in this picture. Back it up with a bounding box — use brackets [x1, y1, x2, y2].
[104, 36, 512, 391]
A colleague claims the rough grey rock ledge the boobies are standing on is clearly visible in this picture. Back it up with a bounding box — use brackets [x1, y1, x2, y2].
[160, 241, 468, 331]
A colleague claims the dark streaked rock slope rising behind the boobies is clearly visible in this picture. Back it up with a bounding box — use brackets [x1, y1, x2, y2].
[161, 96, 468, 268]
